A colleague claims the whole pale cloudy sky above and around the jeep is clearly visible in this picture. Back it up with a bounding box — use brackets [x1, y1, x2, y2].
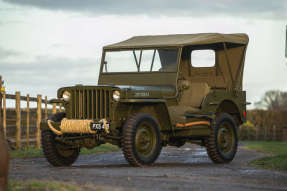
[0, 0, 287, 108]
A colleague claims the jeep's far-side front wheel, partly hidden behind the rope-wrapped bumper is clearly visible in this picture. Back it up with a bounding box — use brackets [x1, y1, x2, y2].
[41, 113, 80, 166]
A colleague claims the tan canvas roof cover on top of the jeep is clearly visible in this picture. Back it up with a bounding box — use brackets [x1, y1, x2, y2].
[104, 33, 248, 50]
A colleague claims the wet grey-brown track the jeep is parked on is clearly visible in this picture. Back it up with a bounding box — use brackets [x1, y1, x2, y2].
[10, 144, 287, 191]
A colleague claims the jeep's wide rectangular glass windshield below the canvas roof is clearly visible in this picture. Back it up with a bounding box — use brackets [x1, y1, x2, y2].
[102, 49, 178, 73]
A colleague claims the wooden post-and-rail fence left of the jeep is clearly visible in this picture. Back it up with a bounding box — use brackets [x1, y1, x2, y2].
[0, 76, 62, 149]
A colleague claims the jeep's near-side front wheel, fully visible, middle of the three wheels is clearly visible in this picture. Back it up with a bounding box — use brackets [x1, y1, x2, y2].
[122, 113, 162, 166]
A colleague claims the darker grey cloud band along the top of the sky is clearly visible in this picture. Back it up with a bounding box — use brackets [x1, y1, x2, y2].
[4, 0, 287, 19]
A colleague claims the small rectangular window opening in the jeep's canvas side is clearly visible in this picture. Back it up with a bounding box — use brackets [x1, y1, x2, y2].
[191, 49, 215, 68]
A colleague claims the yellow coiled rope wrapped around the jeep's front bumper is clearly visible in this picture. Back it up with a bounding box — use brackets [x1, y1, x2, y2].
[48, 118, 110, 135]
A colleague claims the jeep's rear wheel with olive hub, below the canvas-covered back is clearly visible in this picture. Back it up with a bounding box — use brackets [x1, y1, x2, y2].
[206, 113, 238, 163]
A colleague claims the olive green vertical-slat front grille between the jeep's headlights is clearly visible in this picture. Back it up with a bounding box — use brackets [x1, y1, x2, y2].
[71, 87, 112, 120]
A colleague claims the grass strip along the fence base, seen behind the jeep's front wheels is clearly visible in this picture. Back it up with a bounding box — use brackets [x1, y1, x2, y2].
[10, 144, 119, 158]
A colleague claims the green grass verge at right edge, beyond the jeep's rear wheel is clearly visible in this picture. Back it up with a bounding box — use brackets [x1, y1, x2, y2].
[245, 141, 287, 170]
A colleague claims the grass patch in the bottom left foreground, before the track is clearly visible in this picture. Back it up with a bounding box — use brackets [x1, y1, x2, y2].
[8, 180, 83, 191]
